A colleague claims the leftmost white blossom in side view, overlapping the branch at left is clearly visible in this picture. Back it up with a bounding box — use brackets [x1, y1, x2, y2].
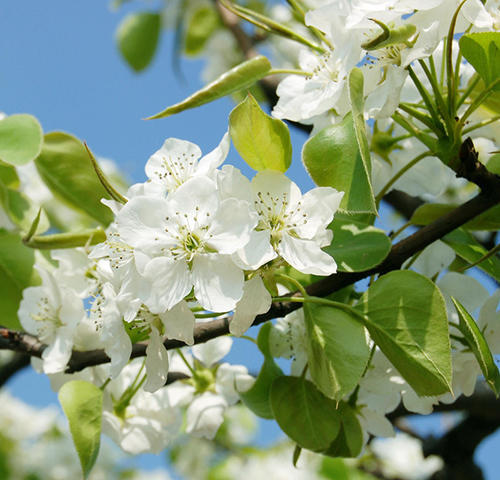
[18, 268, 85, 373]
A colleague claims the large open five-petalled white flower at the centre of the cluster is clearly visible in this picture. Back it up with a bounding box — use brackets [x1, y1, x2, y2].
[116, 177, 256, 313]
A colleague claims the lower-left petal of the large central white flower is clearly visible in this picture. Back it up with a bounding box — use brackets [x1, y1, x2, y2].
[143, 257, 193, 313]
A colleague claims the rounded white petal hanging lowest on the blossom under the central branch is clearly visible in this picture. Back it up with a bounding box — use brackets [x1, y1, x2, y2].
[186, 392, 227, 440]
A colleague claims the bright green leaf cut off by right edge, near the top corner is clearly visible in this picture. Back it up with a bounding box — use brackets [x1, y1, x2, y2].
[458, 32, 500, 92]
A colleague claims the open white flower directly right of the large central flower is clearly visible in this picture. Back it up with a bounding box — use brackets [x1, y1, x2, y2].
[237, 170, 343, 275]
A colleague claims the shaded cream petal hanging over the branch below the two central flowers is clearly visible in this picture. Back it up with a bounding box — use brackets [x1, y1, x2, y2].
[229, 275, 272, 337]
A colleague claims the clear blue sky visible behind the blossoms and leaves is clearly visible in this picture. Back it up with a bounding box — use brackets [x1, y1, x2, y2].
[0, 0, 500, 480]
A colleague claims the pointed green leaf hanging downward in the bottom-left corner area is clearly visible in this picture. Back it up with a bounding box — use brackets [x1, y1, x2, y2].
[59, 380, 102, 478]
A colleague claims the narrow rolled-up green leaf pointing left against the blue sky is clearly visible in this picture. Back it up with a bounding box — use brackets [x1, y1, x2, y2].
[146, 55, 271, 120]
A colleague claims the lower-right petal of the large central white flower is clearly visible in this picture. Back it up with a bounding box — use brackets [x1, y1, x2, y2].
[192, 254, 244, 312]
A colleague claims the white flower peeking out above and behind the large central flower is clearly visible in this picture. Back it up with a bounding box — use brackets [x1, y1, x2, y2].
[146, 133, 230, 192]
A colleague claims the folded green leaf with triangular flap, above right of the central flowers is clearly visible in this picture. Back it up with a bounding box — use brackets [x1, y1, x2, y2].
[302, 113, 377, 213]
